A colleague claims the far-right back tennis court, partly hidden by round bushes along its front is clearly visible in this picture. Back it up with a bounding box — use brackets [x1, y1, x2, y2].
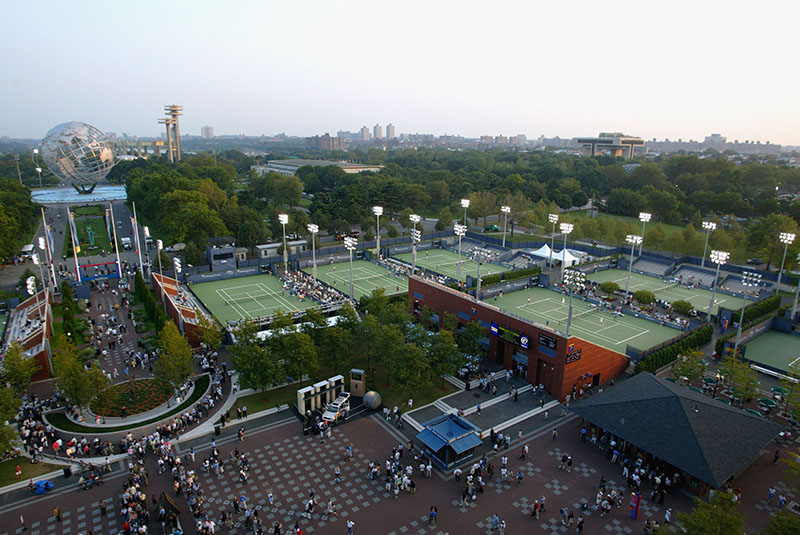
[586, 269, 742, 314]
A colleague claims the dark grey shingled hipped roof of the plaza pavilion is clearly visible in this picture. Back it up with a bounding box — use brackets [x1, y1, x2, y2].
[570, 373, 781, 488]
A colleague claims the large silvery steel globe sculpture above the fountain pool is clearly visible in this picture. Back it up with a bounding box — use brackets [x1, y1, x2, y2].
[39, 121, 114, 193]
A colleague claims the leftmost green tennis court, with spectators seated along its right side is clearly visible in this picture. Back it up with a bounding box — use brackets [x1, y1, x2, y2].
[190, 275, 317, 323]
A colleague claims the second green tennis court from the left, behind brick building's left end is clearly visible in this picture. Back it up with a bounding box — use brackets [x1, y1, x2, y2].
[303, 260, 408, 299]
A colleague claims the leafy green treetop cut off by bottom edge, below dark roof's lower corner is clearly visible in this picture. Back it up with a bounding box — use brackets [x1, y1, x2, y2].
[674, 491, 745, 535]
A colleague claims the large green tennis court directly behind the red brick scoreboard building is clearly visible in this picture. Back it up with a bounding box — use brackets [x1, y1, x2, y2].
[496, 287, 681, 354]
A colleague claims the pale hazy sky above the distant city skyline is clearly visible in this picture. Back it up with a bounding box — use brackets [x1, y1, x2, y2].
[0, 0, 800, 145]
